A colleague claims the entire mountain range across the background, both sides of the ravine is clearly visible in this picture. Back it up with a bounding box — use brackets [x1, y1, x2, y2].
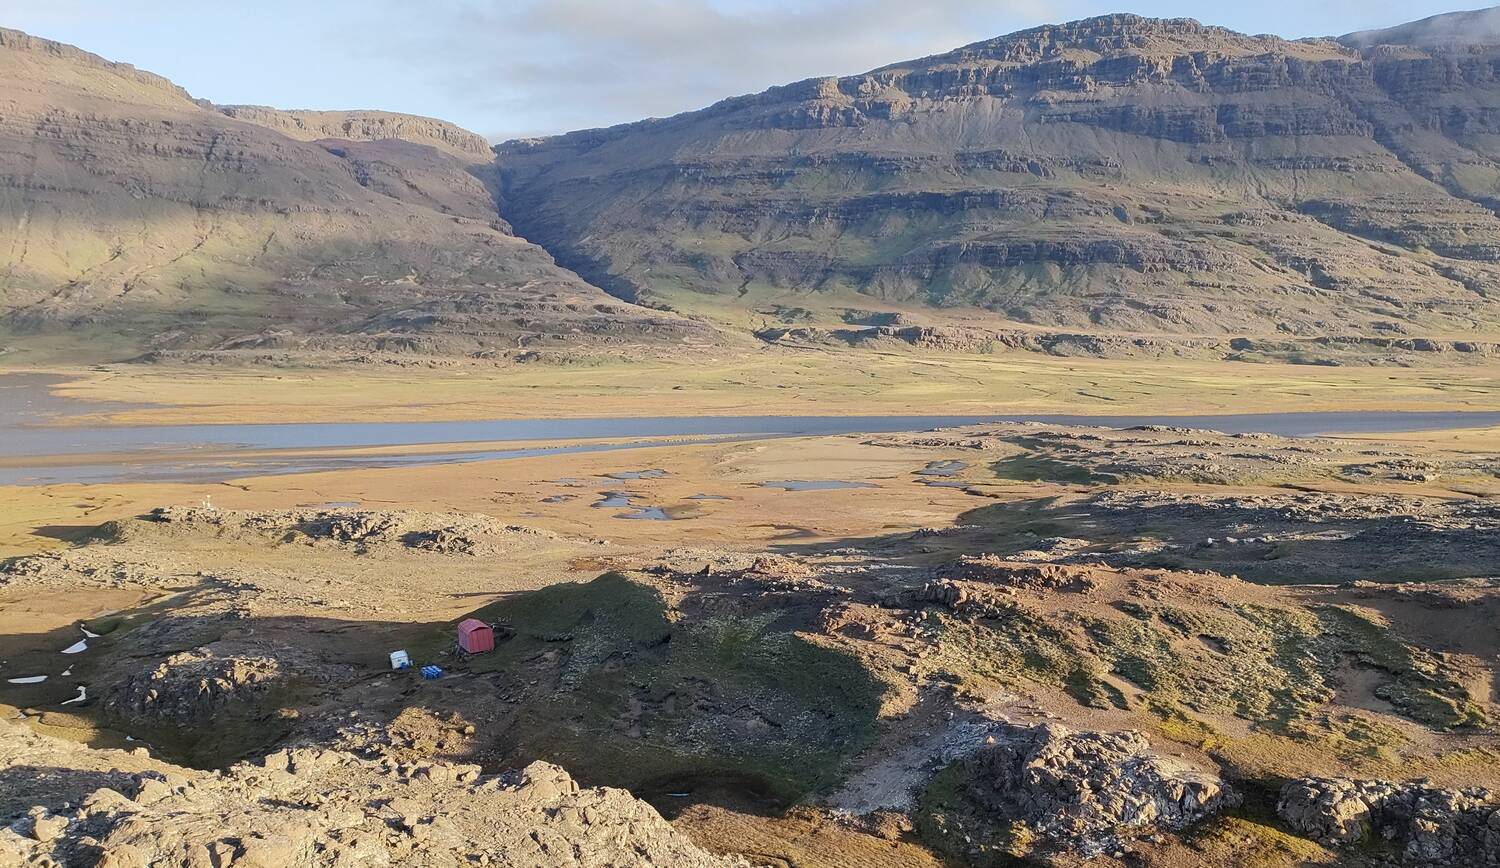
[0, 13, 1500, 361]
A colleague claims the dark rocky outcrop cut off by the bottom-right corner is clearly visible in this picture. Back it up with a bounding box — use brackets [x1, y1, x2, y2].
[1277, 778, 1500, 868]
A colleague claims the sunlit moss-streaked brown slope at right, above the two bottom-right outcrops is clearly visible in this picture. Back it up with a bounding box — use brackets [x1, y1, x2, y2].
[924, 590, 1490, 765]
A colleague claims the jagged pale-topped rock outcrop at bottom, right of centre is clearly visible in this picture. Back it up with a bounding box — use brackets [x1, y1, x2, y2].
[965, 724, 1239, 856]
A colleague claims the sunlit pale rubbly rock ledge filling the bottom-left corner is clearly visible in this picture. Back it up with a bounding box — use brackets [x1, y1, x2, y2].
[0, 723, 734, 868]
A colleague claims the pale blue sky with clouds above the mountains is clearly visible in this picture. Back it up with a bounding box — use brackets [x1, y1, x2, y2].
[0, 0, 1473, 141]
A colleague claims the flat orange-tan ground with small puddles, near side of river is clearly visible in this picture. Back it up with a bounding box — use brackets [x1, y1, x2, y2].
[0, 436, 984, 556]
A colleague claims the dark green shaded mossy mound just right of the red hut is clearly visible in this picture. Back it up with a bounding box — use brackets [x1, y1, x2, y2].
[450, 574, 884, 804]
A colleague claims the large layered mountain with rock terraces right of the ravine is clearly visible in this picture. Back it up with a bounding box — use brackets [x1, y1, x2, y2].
[497, 15, 1500, 356]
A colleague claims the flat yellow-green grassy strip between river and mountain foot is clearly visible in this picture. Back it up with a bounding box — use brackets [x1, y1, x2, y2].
[20, 348, 1500, 424]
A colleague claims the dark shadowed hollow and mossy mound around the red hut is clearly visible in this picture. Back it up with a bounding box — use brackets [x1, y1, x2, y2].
[0, 574, 884, 814]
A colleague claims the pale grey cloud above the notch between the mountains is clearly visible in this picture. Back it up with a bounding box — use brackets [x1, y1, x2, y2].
[355, 0, 1049, 136]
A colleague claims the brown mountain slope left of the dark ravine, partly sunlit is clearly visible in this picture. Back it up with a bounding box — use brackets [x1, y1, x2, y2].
[0, 30, 702, 358]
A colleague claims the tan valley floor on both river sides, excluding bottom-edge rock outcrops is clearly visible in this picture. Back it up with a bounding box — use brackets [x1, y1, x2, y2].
[0, 357, 1500, 865]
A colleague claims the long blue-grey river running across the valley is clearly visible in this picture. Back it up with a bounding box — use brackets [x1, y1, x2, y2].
[0, 373, 1500, 486]
